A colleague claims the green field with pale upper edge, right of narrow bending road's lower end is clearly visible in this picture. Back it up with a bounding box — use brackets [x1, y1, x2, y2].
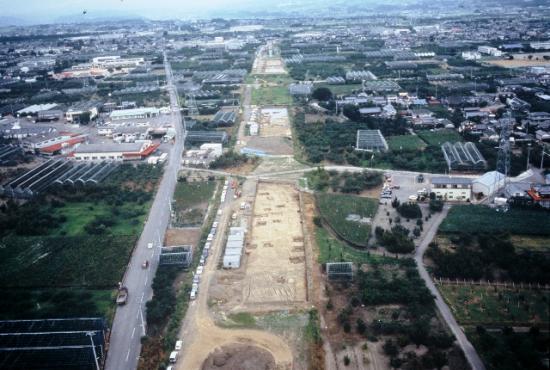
[438, 284, 550, 326]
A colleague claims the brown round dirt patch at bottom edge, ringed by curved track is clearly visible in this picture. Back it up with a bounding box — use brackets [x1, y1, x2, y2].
[202, 344, 275, 370]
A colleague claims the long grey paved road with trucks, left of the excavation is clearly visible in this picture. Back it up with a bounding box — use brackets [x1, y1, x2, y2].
[106, 51, 185, 370]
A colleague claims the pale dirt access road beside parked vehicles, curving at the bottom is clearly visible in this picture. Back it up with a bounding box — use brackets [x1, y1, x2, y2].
[176, 180, 293, 370]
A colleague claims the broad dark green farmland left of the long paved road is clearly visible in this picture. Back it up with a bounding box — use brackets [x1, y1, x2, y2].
[0, 164, 161, 320]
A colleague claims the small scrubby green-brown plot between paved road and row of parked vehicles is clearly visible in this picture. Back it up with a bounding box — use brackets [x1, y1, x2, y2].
[174, 181, 216, 227]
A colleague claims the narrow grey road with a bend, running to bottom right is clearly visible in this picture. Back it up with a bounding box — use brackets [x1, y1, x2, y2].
[414, 206, 485, 370]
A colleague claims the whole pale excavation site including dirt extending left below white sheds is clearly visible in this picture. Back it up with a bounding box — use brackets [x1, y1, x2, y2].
[212, 182, 307, 312]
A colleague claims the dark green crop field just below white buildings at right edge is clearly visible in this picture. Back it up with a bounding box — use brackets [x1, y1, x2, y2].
[439, 205, 550, 235]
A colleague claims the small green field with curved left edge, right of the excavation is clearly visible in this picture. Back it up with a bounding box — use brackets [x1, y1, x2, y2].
[316, 193, 378, 246]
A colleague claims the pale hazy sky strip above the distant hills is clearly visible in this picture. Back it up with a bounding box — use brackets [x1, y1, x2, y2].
[0, 0, 288, 23]
